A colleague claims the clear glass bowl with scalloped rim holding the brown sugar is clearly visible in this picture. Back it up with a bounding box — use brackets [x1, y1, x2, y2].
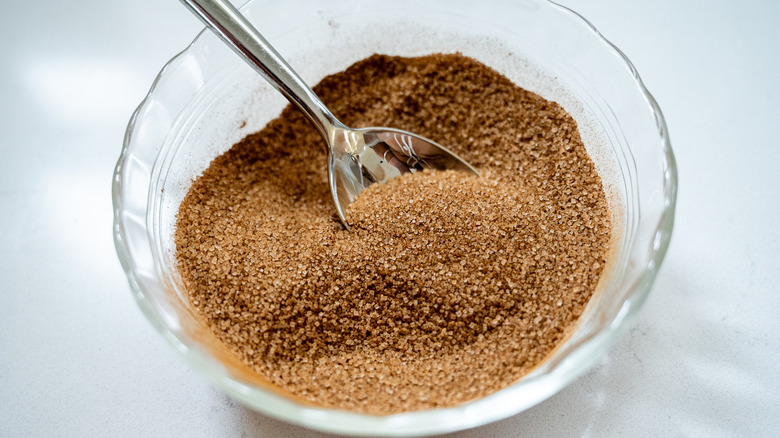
[113, 0, 677, 435]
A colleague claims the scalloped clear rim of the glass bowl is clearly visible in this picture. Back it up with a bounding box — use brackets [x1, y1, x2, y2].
[112, 0, 678, 436]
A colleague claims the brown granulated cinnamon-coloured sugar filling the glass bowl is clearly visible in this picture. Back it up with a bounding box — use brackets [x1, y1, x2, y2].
[175, 54, 611, 414]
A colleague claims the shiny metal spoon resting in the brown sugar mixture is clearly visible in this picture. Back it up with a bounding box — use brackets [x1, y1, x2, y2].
[181, 0, 477, 229]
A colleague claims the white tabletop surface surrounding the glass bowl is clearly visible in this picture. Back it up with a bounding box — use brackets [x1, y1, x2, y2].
[0, 0, 780, 437]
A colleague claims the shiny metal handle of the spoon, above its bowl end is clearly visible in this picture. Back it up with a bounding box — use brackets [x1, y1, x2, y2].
[181, 0, 342, 142]
